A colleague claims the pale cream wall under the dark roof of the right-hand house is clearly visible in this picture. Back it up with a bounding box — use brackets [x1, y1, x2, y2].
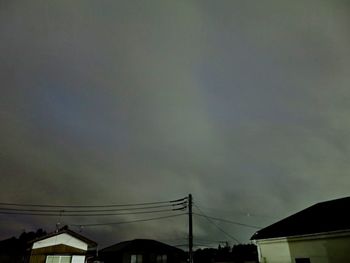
[257, 233, 350, 263]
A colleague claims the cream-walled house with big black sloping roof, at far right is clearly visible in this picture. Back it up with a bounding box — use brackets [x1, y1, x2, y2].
[251, 197, 350, 263]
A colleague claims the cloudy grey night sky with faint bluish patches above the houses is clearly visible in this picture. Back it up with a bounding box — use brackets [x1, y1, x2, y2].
[0, 0, 350, 251]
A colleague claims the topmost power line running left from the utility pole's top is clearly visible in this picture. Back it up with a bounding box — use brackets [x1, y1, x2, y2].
[0, 197, 187, 208]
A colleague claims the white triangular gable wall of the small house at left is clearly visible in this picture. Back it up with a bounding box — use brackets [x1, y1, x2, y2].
[33, 233, 88, 251]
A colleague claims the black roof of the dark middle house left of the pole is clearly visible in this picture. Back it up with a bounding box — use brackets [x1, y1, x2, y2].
[100, 239, 184, 253]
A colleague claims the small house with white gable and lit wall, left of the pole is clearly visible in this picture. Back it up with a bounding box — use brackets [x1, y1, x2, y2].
[29, 228, 97, 263]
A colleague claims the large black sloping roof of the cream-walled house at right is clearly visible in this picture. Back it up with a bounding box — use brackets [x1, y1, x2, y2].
[251, 197, 350, 240]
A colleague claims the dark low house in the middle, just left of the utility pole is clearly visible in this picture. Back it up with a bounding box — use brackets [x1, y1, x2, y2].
[99, 239, 187, 263]
